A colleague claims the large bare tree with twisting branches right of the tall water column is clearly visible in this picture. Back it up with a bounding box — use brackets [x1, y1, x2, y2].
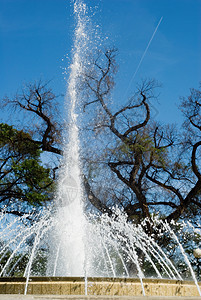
[81, 50, 201, 221]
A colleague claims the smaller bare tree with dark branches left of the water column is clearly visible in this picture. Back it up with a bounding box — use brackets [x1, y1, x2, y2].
[3, 80, 63, 154]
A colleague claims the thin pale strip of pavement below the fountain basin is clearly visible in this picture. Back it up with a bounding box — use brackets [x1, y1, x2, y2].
[0, 294, 201, 300]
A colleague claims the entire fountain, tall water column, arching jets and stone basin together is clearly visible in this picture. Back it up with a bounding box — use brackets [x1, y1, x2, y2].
[0, 0, 201, 296]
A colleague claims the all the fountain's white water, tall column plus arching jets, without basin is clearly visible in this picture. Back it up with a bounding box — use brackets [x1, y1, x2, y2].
[0, 0, 200, 294]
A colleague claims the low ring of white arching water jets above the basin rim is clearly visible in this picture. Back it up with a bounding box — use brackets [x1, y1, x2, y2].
[0, 208, 200, 293]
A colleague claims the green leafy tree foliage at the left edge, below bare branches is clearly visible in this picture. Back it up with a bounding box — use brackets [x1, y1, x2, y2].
[0, 124, 53, 205]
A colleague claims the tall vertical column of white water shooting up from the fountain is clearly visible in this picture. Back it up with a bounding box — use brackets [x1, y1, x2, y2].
[47, 1, 89, 276]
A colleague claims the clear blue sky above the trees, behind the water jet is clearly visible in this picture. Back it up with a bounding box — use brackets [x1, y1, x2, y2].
[0, 0, 201, 123]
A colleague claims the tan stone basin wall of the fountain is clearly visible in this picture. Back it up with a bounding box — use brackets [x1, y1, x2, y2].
[0, 277, 201, 297]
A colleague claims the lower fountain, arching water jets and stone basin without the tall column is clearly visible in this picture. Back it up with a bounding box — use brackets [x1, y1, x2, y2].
[0, 208, 201, 296]
